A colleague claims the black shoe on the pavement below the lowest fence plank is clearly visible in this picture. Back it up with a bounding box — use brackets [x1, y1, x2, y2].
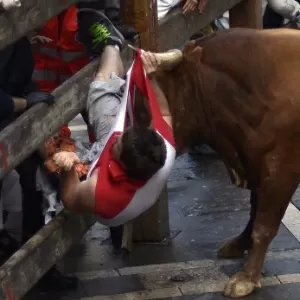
[37, 267, 78, 290]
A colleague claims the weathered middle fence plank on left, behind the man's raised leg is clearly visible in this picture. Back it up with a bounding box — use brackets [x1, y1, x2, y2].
[0, 49, 132, 179]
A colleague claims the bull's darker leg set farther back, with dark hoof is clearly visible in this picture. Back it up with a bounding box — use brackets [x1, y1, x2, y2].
[218, 191, 257, 258]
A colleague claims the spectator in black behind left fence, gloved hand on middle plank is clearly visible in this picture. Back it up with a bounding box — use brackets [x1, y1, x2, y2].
[0, 37, 77, 288]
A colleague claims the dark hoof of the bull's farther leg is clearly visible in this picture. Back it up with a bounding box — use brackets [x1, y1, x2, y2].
[218, 236, 248, 258]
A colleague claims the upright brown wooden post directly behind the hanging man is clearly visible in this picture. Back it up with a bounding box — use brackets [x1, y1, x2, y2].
[121, 0, 169, 242]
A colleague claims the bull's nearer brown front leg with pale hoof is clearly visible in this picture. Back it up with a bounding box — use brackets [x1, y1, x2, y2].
[224, 166, 299, 298]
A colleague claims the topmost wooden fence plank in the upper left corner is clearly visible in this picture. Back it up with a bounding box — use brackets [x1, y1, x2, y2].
[0, 0, 78, 50]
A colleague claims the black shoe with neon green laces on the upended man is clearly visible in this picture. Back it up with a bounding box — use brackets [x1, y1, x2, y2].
[78, 8, 124, 55]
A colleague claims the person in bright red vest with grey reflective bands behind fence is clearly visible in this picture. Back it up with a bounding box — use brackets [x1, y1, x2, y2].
[32, 0, 136, 142]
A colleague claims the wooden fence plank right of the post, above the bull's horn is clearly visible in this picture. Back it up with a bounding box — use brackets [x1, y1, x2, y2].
[158, 0, 242, 51]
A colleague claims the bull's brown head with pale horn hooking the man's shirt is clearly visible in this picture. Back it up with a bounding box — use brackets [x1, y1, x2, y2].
[148, 41, 205, 152]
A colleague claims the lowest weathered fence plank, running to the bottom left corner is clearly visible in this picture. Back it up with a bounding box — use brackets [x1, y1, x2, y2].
[0, 210, 96, 300]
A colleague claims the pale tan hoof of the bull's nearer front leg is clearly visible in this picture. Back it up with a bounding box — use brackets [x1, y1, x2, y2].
[224, 272, 261, 298]
